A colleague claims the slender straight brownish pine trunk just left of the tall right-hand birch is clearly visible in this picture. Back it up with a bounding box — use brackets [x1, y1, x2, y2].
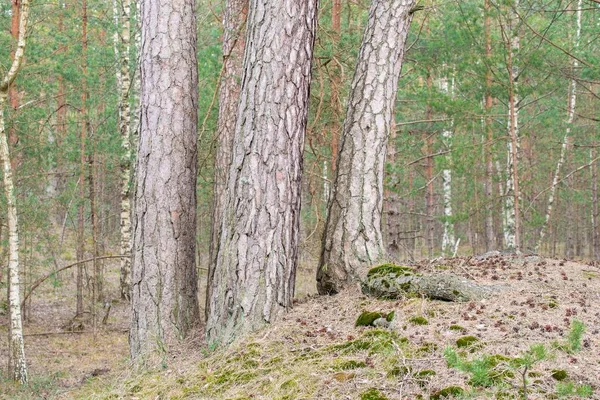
[484, 0, 496, 251]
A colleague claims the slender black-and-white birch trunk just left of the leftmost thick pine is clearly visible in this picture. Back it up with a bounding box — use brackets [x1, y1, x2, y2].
[113, 0, 132, 300]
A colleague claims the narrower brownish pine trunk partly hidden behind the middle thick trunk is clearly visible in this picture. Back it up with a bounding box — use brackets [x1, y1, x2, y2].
[205, 0, 248, 317]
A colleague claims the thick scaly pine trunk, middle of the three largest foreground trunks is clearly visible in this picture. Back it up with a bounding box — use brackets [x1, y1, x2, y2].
[207, 0, 317, 343]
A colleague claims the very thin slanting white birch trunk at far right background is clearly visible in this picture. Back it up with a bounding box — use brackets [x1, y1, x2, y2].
[535, 0, 583, 251]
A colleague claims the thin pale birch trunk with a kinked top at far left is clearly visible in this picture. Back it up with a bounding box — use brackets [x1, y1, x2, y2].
[0, 0, 29, 384]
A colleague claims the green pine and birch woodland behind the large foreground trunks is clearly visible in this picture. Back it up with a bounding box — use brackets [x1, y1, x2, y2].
[0, 0, 600, 310]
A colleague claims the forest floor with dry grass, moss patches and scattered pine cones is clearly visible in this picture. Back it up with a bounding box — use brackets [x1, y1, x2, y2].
[0, 256, 600, 400]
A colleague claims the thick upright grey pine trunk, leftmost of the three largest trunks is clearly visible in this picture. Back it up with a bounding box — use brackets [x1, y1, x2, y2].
[129, 0, 199, 363]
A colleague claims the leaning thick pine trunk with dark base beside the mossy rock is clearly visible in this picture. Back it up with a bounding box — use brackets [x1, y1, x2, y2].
[317, 0, 415, 294]
